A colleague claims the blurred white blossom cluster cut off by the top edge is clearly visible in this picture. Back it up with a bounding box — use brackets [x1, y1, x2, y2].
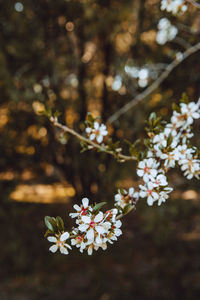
[160, 0, 187, 14]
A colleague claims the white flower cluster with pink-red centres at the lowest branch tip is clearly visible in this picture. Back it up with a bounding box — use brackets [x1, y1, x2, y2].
[47, 198, 122, 255]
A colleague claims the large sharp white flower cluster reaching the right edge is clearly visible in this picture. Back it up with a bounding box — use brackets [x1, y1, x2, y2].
[137, 102, 200, 205]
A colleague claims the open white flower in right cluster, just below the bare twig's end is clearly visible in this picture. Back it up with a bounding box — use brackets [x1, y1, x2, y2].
[137, 158, 160, 182]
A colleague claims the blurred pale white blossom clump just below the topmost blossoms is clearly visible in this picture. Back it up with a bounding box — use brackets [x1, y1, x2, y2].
[156, 18, 178, 45]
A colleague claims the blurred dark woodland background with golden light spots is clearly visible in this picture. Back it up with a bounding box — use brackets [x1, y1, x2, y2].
[0, 0, 200, 300]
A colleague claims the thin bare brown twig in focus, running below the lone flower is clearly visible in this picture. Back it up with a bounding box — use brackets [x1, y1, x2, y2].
[50, 117, 137, 162]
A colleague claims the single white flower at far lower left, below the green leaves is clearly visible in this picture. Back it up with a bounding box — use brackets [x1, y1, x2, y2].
[47, 232, 72, 255]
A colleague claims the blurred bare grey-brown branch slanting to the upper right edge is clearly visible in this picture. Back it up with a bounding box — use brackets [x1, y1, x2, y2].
[107, 42, 200, 124]
